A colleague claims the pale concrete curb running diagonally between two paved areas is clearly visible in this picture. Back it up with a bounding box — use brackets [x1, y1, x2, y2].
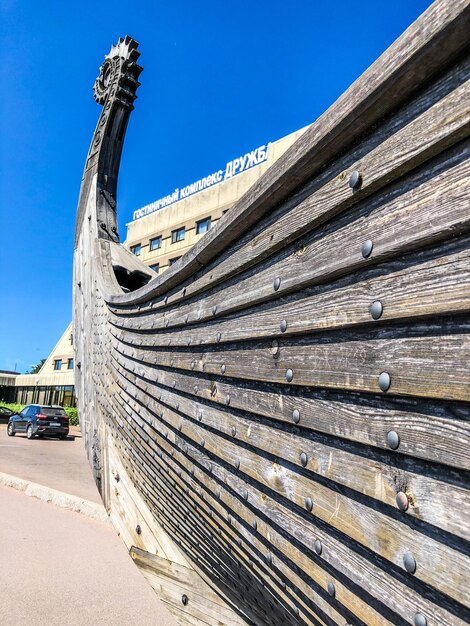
[0, 472, 109, 523]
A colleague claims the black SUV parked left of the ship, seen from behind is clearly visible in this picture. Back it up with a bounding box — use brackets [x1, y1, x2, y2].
[7, 404, 69, 439]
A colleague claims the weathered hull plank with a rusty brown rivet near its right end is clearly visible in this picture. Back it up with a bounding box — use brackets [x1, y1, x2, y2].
[113, 364, 470, 540]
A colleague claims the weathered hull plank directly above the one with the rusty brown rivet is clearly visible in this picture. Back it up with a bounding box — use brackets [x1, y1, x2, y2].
[109, 332, 470, 470]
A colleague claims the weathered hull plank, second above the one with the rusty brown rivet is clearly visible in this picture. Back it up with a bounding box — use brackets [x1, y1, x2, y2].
[114, 324, 470, 401]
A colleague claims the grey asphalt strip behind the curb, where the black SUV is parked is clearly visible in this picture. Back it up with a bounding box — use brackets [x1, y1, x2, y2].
[0, 424, 101, 503]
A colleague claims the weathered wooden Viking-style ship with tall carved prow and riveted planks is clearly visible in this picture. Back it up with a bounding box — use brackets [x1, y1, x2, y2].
[74, 0, 470, 626]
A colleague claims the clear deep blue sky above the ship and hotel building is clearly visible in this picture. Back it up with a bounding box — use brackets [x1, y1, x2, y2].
[0, 0, 431, 372]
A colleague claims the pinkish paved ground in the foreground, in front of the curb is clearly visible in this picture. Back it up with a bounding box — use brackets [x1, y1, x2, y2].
[0, 482, 177, 626]
